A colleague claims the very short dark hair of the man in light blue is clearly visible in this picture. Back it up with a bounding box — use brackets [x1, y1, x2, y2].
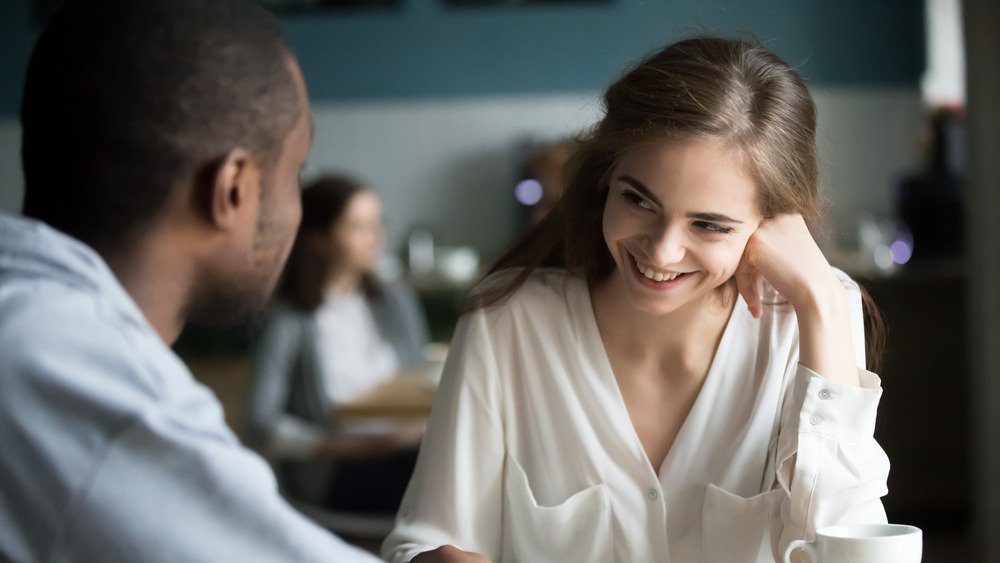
[21, 0, 301, 251]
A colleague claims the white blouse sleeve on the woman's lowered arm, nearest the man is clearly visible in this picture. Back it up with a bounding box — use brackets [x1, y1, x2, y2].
[382, 310, 504, 563]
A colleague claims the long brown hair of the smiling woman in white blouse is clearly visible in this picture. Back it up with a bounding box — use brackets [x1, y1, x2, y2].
[463, 37, 885, 369]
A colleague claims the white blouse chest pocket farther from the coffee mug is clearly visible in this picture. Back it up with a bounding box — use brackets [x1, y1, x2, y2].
[501, 454, 612, 563]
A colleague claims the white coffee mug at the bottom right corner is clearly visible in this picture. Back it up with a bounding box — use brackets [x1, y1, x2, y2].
[785, 524, 924, 563]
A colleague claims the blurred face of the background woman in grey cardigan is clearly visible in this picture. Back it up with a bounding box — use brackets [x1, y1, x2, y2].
[330, 191, 383, 273]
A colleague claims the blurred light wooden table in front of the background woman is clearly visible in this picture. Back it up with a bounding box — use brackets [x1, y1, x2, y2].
[333, 370, 434, 421]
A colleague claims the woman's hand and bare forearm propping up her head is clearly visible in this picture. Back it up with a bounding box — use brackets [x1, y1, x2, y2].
[736, 214, 860, 385]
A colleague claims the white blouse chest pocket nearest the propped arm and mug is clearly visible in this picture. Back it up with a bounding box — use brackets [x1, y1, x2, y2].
[702, 484, 783, 563]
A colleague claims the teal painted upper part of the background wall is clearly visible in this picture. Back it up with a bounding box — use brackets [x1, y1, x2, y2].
[0, 0, 924, 115]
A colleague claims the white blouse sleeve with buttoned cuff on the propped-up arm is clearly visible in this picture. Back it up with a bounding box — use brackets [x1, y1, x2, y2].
[772, 276, 889, 559]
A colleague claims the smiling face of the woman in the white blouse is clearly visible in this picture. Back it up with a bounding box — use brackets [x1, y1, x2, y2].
[604, 139, 762, 314]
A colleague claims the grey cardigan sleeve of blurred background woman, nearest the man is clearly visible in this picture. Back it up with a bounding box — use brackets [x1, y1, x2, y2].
[246, 310, 326, 459]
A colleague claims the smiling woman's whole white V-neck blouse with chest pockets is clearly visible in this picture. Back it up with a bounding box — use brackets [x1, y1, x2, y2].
[383, 270, 889, 563]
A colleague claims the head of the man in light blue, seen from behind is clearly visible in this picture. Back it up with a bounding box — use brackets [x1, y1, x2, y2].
[21, 0, 311, 328]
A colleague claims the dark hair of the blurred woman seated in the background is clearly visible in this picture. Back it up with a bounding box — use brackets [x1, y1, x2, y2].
[278, 175, 381, 312]
